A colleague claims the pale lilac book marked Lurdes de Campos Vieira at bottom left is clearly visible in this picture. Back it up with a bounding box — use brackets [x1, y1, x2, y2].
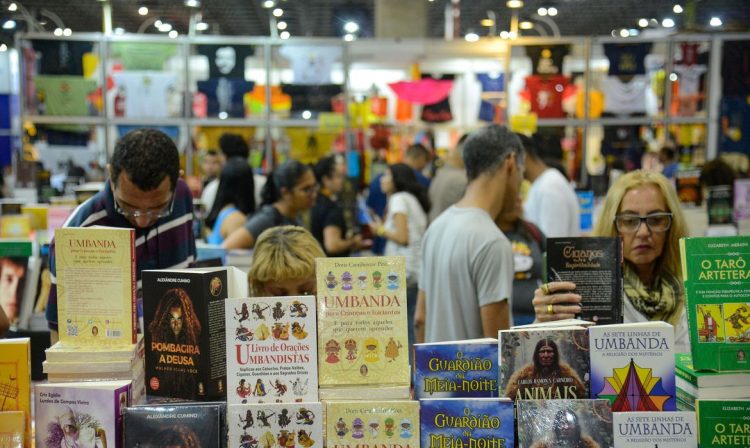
[34, 381, 130, 448]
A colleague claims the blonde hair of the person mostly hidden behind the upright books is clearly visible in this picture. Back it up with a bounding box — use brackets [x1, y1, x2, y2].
[247, 226, 325, 296]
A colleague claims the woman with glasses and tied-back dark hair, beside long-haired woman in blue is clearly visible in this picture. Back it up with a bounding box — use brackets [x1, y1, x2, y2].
[222, 160, 318, 249]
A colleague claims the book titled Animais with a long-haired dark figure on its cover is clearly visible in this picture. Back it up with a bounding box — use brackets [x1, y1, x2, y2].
[498, 328, 589, 401]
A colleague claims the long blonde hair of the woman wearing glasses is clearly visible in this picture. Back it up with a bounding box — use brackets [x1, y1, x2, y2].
[593, 170, 688, 280]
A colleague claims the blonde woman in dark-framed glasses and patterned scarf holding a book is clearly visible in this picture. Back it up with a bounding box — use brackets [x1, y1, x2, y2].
[533, 170, 690, 352]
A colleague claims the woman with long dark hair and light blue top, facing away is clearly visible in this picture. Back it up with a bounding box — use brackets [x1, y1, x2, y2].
[206, 157, 255, 244]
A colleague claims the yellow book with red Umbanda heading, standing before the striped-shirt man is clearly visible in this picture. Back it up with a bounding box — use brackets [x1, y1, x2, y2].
[55, 227, 137, 345]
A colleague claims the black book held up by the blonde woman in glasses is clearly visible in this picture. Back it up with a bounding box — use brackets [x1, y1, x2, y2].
[546, 237, 623, 325]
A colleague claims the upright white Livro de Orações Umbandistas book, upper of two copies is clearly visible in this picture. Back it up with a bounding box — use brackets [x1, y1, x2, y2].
[225, 296, 318, 404]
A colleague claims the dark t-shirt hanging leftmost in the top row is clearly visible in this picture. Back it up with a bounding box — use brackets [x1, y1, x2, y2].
[31, 40, 94, 76]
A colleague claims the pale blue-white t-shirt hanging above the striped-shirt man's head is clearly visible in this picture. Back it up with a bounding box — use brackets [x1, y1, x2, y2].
[112, 71, 177, 118]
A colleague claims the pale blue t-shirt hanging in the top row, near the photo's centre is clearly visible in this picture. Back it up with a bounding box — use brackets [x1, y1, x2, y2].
[279, 45, 341, 84]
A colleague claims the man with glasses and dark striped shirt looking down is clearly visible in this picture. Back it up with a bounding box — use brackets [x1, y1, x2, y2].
[46, 129, 195, 344]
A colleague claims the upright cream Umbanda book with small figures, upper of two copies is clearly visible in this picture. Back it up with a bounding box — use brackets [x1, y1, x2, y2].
[316, 257, 410, 399]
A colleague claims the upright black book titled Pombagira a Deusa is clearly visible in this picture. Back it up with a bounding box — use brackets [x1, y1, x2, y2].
[143, 268, 247, 401]
